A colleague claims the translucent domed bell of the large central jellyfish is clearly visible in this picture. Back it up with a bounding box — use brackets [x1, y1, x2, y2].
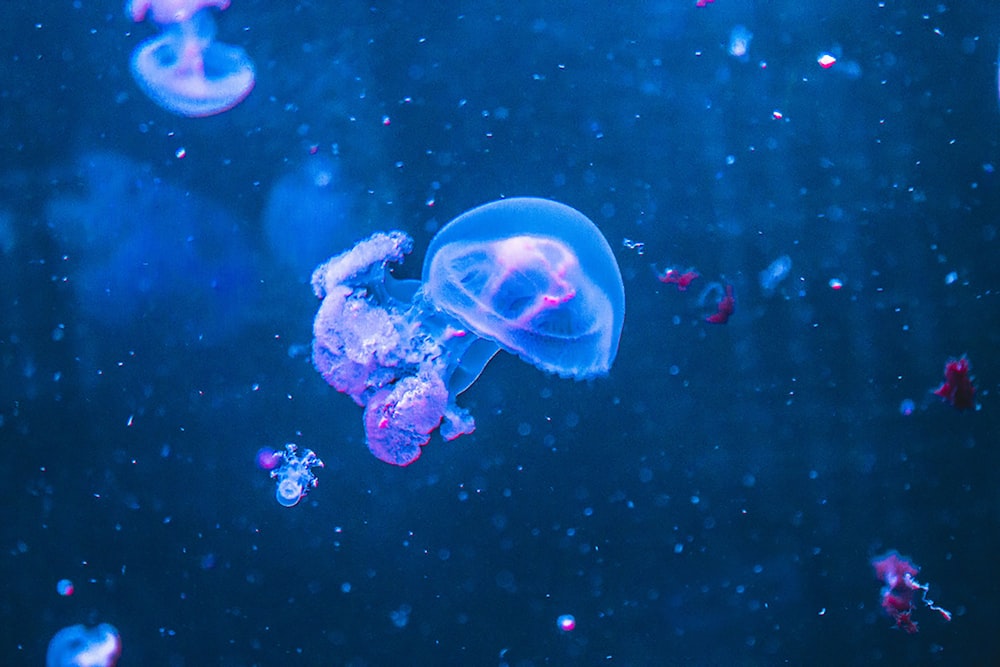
[423, 198, 625, 384]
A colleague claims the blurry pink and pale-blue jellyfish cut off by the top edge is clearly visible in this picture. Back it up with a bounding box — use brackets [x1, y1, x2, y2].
[126, 0, 254, 117]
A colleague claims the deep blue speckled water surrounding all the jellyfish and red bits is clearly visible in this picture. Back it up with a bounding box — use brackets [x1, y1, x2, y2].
[0, 0, 1000, 666]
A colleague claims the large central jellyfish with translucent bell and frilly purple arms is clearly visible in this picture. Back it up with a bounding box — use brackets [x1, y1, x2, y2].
[312, 198, 625, 466]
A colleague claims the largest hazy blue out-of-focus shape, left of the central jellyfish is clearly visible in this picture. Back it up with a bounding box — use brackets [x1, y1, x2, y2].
[45, 153, 258, 342]
